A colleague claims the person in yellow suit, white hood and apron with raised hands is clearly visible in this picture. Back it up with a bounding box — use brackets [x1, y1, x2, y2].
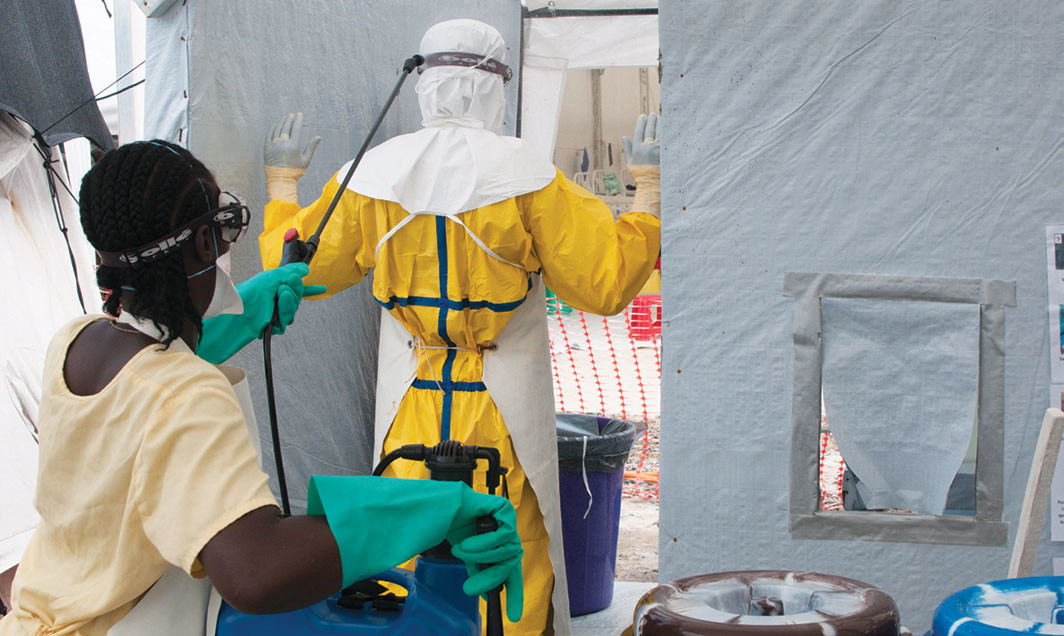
[260, 20, 661, 635]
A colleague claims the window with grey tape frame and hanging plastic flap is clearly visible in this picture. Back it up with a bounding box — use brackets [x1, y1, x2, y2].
[784, 273, 1016, 546]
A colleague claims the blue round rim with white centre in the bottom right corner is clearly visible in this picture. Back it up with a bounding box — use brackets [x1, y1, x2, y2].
[927, 576, 1064, 636]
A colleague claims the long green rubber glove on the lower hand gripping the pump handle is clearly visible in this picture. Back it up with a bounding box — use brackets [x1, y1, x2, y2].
[306, 475, 525, 622]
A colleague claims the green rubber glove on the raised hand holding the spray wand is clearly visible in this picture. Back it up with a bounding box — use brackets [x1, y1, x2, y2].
[196, 263, 326, 365]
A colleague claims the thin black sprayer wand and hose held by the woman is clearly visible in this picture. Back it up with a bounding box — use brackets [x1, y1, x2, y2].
[262, 55, 425, 517]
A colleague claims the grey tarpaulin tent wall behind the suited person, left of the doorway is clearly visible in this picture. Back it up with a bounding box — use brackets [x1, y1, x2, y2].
[145, 0, 520, 511]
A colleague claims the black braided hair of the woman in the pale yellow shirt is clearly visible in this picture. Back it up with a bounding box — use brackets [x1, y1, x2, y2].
[80, 139, 218, 347]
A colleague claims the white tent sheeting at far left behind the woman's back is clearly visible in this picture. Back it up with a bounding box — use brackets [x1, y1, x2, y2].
[0, 113, 99, 571]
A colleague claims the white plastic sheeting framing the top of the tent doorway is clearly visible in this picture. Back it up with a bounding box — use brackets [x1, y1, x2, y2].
[521, 13, 658, 165]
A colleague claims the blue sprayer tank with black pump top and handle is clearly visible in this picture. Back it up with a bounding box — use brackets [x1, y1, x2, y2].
[216, 440, 506, 636]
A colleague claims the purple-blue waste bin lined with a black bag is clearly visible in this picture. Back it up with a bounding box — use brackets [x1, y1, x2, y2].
[556, 413, 636, 616]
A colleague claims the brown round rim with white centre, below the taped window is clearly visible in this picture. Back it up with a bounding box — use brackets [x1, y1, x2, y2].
[626, 570, 899, 636]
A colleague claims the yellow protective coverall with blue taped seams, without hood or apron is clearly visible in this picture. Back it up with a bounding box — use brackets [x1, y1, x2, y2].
[259, 172, 661, 634]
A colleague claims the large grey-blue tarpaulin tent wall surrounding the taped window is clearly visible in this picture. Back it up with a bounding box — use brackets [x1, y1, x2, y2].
[660, 0, 1064, 633]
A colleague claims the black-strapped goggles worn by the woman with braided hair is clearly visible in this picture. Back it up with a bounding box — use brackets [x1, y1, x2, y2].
[97, 190, 251, 269]
